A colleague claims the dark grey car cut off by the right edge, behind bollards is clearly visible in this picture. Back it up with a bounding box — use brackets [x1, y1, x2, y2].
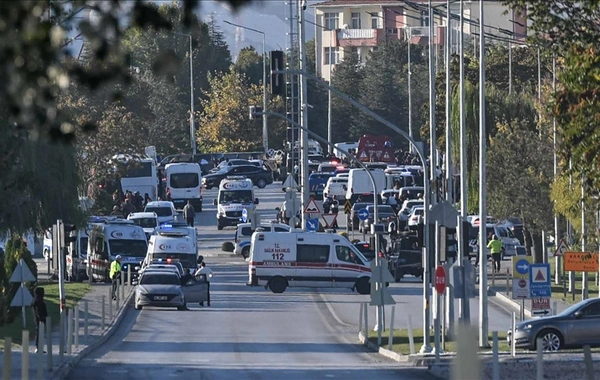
[506, 298, 600, 351]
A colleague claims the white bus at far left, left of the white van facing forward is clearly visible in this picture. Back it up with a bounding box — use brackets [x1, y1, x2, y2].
[113, 154, 159, 201]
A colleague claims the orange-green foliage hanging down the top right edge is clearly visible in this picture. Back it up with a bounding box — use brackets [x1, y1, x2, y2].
[505, 0, 600, 196]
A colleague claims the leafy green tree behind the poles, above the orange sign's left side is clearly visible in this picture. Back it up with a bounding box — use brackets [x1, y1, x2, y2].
[486, 120, 553, 262]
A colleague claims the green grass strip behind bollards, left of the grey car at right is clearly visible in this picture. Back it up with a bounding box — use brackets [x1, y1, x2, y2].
[369, 329, 510, 355]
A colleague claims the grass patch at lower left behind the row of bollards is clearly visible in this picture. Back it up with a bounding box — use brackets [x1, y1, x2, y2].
[0, 283, 90, 350]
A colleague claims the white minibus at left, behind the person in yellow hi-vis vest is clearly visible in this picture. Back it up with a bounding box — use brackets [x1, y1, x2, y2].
[88, 219, 148, 282]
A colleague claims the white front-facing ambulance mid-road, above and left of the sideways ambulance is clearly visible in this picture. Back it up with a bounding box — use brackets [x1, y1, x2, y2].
[213, 176, 258, 230]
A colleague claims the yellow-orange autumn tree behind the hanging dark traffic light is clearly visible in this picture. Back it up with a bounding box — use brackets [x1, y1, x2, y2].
[197, 67, 285, 152]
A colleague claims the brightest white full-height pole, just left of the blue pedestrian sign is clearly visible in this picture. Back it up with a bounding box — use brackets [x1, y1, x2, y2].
[479, 0, 489, 347]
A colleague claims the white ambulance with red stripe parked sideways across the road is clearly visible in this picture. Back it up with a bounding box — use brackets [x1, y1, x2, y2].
[248, 231, 371, 294]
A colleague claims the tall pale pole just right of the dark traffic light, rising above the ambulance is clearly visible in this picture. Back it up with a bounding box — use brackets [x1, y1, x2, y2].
[298, 0, 309, 229]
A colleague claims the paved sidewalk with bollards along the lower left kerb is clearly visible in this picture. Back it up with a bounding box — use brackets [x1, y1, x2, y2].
[0, 284, 134, 380]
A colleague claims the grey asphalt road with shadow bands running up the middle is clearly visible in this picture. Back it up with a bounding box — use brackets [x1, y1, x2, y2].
[68, 185, 510, 380]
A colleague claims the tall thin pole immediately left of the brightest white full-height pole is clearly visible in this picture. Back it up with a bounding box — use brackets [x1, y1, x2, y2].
[458, 0, 471, 325]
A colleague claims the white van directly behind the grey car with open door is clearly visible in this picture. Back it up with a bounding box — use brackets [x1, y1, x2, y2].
[142, 230, 198, 275]
